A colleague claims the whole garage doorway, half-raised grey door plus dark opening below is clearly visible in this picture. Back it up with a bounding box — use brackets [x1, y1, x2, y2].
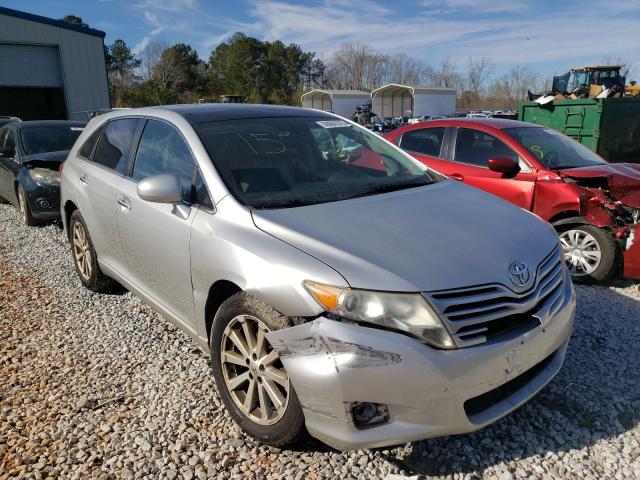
[0, 43, 67, 120]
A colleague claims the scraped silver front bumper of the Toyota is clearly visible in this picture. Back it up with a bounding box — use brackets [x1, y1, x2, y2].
[267, 282, 575, 450]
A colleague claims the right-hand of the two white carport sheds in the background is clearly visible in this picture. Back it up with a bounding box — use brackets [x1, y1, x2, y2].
[371, 83, 456, 118]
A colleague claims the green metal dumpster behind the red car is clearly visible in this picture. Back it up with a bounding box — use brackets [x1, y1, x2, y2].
[518, 97, 640, 163]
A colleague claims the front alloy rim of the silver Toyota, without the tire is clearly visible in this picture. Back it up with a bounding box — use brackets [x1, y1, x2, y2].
[220, 315, 289, 425]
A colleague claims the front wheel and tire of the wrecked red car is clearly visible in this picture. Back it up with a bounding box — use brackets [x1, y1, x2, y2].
[558, 225, 618, 285]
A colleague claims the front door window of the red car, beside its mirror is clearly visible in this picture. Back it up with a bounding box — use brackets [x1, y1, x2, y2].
[454, 128, 519, 167]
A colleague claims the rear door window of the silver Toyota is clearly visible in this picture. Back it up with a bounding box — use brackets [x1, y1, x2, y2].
[93, 118, 138, 173]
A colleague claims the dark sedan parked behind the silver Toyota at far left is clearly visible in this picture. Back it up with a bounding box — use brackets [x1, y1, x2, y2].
[0, 120, 85, 225]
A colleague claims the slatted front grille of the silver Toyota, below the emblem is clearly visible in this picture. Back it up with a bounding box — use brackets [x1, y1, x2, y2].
[425, 247, 564, 347]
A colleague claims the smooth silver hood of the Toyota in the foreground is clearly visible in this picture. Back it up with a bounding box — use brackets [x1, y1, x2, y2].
[252, 180, 557, 292]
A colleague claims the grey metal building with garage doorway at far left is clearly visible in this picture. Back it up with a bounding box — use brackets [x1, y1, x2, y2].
[0, 7, 111, 120]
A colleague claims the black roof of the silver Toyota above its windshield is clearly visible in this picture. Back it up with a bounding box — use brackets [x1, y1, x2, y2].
[157, 103, 334, 123]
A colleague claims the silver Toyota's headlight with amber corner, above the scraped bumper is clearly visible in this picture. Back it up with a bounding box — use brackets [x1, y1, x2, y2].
[304, 280, 455, 348]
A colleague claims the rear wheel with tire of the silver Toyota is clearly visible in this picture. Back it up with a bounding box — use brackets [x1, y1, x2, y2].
[69, 210, 116, 292]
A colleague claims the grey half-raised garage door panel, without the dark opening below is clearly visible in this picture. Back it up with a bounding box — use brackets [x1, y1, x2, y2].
[0, 43, 62, 87]
